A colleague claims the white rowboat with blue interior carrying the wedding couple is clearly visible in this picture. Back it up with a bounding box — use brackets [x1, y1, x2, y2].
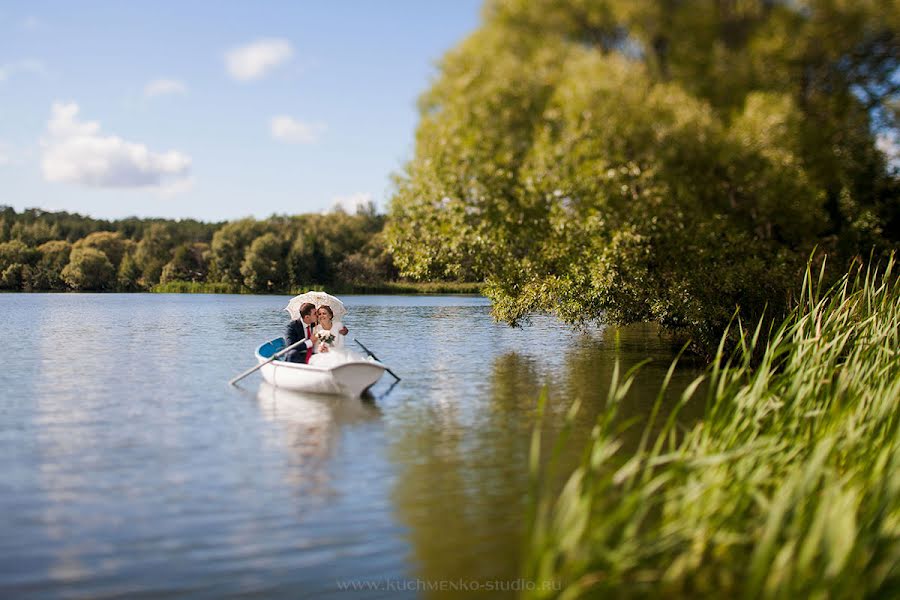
[256, 338, 385, 397]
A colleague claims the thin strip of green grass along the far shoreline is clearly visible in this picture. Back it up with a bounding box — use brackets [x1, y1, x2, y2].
[150, 281, 484, 295]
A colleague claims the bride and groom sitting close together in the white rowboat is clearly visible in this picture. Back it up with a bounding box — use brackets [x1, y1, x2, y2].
[284, 302, 365, 368]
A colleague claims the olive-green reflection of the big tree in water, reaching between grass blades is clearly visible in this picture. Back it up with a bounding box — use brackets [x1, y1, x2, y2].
[391, 326, 708, 597]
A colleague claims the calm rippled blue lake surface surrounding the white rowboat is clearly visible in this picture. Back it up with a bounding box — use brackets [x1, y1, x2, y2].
[0, 294, 695, 598]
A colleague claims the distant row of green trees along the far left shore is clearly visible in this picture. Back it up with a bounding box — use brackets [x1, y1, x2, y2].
[0, 206, 396, 293]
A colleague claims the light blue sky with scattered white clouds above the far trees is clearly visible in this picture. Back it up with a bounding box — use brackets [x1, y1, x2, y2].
[0, 0, 481, 220]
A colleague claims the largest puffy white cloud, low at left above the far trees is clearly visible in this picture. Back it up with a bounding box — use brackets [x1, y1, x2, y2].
[41, 102, 191, 188]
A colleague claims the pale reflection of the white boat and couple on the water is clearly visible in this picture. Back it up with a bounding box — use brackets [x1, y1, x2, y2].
[256, 383, 380, 499]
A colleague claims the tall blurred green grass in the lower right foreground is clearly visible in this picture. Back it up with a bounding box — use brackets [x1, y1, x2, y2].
[524, 257, 900, 598]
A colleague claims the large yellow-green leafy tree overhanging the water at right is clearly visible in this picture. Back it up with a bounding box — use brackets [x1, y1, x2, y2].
[387, 0, 900, 344]
